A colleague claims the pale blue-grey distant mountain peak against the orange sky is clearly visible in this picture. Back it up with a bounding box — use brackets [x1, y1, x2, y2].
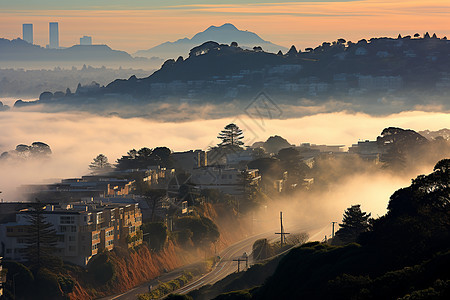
[135, 23, 287, 59]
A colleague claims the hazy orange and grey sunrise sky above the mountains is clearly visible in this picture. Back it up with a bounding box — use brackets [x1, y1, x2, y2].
[0, 0, 450, 53]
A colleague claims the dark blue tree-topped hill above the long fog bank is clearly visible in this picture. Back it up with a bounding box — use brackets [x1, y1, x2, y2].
[13, 34, 450, 113]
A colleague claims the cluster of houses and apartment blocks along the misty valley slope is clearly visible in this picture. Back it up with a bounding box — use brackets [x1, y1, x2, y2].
[0, 141, 383, 266]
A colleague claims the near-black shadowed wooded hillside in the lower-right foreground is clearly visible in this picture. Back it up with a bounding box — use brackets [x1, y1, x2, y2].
[207, 159, 450, 299]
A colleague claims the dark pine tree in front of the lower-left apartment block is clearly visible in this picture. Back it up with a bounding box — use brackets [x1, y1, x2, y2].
[25, 203, 58, 270]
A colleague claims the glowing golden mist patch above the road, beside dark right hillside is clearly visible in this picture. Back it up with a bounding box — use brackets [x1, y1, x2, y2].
[254, 169, 414, 240]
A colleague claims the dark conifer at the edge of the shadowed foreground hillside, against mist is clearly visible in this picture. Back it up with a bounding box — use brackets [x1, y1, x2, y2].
[336, 204, 370, 244]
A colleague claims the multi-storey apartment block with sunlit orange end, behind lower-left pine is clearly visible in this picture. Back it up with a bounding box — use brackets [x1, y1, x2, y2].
[0, 202, 142, 266]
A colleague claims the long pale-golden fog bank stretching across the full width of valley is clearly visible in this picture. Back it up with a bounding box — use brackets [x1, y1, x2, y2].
[0, 111, 450, 201]
